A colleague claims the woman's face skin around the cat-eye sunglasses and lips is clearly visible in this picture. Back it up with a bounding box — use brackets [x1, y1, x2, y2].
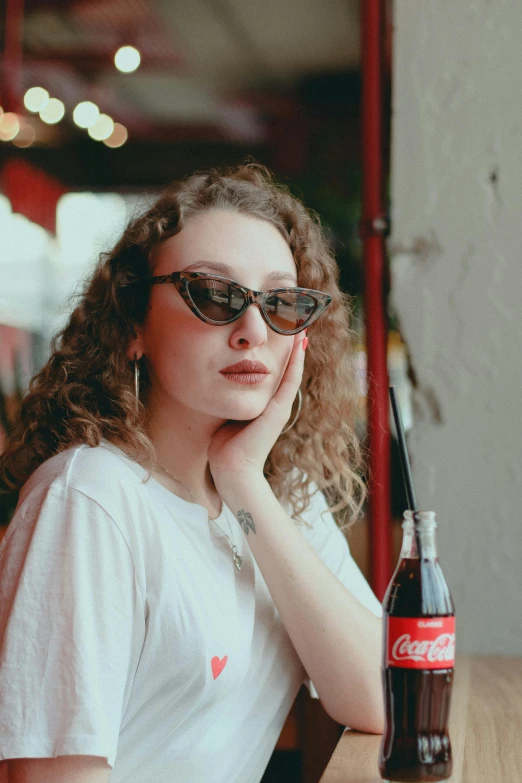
[128, 209, 297, 428]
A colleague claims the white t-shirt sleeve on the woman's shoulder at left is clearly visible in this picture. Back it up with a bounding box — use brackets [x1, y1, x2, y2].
[0, 483, 144, 767]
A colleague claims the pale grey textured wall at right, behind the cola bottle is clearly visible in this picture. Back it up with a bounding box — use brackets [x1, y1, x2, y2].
[390, 0, 522, 655]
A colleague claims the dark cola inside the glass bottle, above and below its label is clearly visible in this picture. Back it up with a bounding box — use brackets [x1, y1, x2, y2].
[379, 558, 455, 783]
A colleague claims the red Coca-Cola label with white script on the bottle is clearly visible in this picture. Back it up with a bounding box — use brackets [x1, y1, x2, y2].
[386, 617, 455, 669]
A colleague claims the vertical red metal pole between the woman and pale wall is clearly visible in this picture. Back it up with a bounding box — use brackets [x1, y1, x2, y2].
[361, 0, 393, 601]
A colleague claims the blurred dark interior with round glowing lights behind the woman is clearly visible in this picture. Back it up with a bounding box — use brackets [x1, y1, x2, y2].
[0, 0, 402, 783]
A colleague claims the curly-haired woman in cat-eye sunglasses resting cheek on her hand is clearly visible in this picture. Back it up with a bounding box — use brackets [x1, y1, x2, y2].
[0, 164, 383, 783]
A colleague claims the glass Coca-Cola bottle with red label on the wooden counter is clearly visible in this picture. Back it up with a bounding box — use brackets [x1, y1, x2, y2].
[379, 511, 455, 783]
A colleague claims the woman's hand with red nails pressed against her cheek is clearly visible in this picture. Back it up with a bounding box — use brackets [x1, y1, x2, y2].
[208, 330, 306, 492]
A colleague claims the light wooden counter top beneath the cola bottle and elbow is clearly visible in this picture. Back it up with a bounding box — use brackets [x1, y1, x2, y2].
[320, 654, 522, 783]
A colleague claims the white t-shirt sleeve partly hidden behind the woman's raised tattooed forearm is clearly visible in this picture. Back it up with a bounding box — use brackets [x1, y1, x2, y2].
[299, 483, 383, 699]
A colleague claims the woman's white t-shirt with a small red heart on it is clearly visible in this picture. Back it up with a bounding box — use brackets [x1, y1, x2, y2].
[0, 443, 382, 783]
